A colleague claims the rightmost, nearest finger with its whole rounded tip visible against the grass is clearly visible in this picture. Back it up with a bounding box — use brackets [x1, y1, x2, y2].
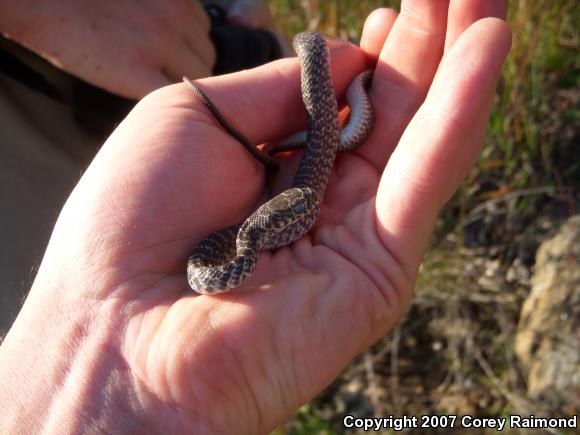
[376, 18, 510, 274]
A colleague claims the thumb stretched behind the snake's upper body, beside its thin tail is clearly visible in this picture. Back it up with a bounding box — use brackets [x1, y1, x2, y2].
[180, 44, 367, 144]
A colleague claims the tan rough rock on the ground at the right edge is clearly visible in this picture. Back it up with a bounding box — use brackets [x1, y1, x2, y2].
[516, 215, 580, 410]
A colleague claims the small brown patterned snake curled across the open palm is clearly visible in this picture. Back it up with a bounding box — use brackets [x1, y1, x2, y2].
[184, 31, 375, 295]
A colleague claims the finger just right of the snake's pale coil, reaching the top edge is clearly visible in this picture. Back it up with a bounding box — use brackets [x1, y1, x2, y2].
[358, 0, 449, 170]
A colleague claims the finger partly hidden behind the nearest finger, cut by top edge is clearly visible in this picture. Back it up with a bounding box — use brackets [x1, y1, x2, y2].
[445, 0, 507, 52]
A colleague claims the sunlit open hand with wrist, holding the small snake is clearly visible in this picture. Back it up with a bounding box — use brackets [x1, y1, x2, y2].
[0, 0, 511, 434]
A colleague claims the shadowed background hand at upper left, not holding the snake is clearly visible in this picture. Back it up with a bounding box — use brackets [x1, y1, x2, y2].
[0, 0, 216, 99]
